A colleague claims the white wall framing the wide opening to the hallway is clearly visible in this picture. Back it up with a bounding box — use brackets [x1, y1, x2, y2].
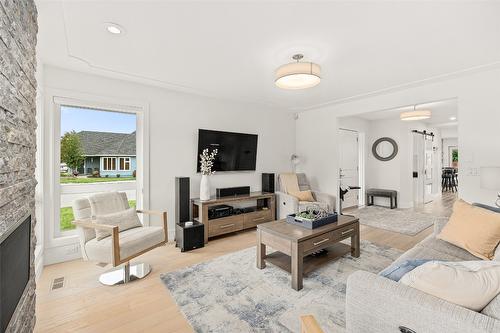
[296, 67, 500, 208]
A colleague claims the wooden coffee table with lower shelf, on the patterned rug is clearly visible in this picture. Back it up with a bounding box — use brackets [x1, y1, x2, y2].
[257, 215, 359, 290]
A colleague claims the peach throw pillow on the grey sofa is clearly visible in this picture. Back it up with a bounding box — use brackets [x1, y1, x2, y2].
[437, 200, 500, 260]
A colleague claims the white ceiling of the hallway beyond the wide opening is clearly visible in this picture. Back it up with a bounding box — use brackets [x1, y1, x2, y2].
[356, 99, 458, 127]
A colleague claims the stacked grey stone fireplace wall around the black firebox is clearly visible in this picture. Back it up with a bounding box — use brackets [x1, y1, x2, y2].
[0, 0, 38, 332]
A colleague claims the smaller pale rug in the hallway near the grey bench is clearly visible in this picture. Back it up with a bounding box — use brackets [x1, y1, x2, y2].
[347, 206, 448, 236]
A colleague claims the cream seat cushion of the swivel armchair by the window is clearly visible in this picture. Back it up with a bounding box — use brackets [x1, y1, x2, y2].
[85, 227, 165, 263]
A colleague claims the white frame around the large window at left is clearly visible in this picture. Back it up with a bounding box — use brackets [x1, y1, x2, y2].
[43, 88, 150, 263]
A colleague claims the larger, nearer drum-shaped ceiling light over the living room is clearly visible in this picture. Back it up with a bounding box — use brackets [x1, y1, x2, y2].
[274, 54, 321, 89]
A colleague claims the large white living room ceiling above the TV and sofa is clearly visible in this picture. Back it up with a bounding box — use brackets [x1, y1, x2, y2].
[37, 0, 500, 110]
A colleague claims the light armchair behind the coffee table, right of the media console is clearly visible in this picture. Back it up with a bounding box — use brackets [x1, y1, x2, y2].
[275, 173, 337, 219]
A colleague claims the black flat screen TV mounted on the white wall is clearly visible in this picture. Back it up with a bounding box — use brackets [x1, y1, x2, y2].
[197, 129, 258, 172]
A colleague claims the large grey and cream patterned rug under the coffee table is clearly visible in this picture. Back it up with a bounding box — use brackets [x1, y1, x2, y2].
[161, 241, 401, 333]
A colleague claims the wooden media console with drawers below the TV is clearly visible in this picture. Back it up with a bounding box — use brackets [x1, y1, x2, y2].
[191, 192, 276, 244]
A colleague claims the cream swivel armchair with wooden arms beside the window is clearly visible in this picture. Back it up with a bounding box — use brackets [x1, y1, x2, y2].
[73, 192, 168, 285]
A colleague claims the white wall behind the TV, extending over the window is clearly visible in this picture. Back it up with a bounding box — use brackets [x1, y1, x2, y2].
[44, 66, 295, 263]
